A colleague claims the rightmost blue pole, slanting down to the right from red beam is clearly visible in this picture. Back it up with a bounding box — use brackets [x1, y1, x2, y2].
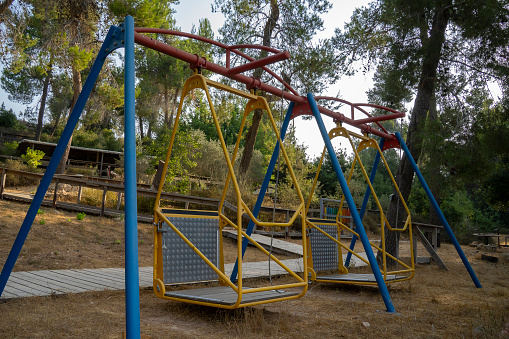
[396, 132, 482, 288]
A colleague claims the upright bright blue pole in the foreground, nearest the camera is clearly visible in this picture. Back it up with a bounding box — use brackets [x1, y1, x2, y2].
[124, 16, 141, 339]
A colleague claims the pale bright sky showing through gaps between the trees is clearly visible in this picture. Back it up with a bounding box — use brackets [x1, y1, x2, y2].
[0, 0, 373, 158]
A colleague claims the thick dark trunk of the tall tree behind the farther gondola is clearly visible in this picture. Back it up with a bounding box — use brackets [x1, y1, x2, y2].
[378, 8, 450, 268]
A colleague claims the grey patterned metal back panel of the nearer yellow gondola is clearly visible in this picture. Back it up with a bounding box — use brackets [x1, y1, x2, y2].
[162, 217, 219, 284]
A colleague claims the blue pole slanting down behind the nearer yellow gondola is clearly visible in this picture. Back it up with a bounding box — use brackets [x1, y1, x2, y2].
[230, 102, 295, 281]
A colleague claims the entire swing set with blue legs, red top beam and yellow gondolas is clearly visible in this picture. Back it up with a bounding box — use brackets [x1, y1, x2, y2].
[0, 16, 481, 338]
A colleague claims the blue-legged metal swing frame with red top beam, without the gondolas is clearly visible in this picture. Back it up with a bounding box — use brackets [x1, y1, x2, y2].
[0, 16, 482, 338]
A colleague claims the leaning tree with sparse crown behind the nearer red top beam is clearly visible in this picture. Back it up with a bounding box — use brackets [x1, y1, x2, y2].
[212, 0, 337, 172]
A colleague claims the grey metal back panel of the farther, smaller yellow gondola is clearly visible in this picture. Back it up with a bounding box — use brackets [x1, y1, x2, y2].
[309, 224, 339, 272]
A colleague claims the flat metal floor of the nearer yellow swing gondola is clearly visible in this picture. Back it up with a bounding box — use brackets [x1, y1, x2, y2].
[164, 286, 299, 306]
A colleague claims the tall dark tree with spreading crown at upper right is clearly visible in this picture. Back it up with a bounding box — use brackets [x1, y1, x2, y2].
[334, 0, 509, 264]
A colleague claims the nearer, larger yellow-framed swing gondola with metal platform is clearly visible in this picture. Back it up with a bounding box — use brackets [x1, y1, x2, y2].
[154, 72, 308, 309]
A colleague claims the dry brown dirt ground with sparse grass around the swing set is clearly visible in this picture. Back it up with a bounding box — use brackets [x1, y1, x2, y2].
[0, 200, 509, 338]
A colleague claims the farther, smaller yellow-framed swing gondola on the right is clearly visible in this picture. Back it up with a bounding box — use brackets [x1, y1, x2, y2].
[306, 125, 415, 285]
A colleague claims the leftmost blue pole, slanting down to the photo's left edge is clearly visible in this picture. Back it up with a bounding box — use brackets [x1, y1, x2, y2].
[0, 26, 123, 296]
